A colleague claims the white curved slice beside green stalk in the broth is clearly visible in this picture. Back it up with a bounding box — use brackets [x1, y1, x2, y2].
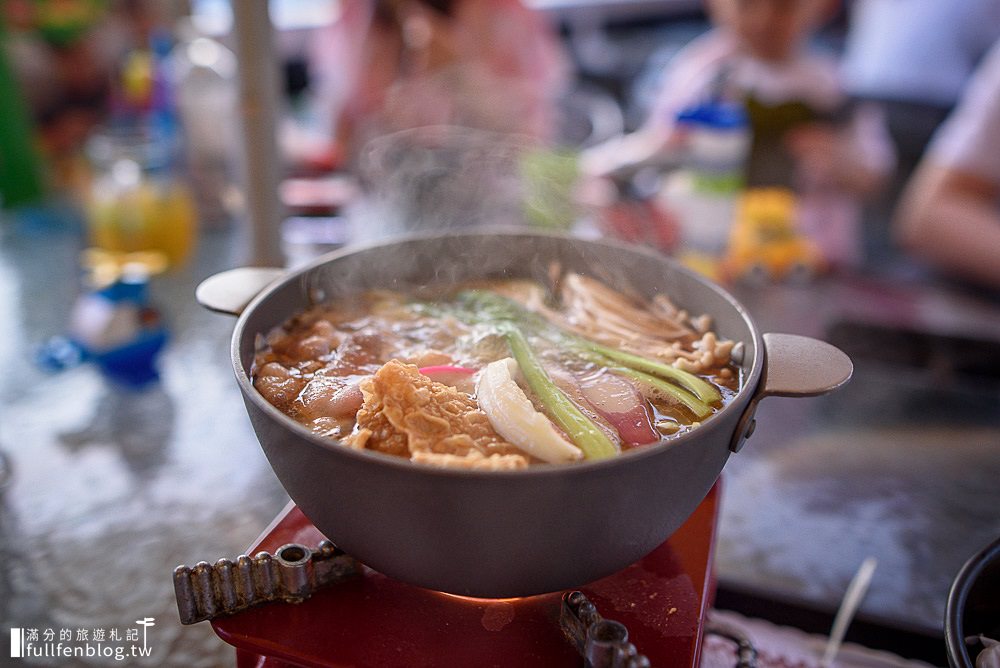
[476, 357, 583, 464]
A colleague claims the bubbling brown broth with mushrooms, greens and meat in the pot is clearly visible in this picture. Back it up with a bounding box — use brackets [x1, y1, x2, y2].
[252, 273, 740, 470]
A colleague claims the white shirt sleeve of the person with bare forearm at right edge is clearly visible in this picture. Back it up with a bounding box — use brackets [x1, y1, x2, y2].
[929, 41, 1000, 184]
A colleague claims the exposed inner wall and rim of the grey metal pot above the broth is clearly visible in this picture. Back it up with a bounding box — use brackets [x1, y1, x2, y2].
[232, 230, 763, 459]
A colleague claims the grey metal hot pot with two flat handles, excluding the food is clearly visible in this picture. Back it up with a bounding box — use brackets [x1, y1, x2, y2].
[197, 231, 852, 598]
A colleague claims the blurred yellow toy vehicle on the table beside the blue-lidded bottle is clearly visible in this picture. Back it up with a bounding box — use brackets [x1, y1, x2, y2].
[723, 188, 825, 280]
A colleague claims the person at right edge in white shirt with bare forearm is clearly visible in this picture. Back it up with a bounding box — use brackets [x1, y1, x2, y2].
[894, 41, 1000, 288]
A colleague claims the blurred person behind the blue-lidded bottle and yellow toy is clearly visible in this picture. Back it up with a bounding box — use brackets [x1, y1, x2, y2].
[583, 0, 894, 264]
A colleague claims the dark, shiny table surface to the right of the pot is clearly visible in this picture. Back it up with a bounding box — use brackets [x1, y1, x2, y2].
[717, 266, 1000, 634]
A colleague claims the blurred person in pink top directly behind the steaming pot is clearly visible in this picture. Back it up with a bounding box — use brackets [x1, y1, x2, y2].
[312, 0, 568, 170]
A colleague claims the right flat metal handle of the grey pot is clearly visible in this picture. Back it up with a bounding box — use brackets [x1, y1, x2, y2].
[729, 333, 854, 452]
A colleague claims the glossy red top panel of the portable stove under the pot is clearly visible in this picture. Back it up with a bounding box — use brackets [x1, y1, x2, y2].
[212, 485, 719, 668]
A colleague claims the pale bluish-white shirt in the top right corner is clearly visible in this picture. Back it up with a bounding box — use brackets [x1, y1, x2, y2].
[842, 0, 1000, 107]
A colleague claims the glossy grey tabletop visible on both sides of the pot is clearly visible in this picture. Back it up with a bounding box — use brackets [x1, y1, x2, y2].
[0, 206, 1000, 666]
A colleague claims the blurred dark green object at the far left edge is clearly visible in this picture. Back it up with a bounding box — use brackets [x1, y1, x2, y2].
[0, 21, 45, 209]
